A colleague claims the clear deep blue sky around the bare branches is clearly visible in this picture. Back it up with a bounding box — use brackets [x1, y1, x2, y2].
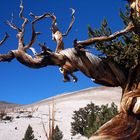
[0, 0, 126, 104]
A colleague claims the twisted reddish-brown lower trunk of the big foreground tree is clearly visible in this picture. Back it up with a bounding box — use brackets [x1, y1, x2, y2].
[90, 66, 140, 140]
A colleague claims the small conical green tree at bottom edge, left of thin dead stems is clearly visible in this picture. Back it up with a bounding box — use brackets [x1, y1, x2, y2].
[22, 125, 34, 140]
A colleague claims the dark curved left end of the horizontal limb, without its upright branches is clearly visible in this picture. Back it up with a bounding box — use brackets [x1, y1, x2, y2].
[0, 50, 65, 69]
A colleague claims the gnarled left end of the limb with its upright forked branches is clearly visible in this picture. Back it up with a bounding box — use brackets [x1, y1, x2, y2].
[0, 1, 64, 68]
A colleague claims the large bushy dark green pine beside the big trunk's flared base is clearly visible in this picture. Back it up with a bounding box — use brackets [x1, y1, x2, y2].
[71, 103, 118, 138]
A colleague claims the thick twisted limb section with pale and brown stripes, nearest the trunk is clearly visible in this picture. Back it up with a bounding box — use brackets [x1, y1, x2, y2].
[60, 48, 126, 87]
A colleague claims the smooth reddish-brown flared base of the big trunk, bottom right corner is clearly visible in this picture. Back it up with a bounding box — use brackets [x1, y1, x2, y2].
[89, 113, 140, 140]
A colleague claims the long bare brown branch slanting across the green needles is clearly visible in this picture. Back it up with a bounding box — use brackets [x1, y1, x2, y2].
[77, 23, 134, 47]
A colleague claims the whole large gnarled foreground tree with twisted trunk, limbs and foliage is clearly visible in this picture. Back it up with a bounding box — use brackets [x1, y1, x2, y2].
[0, 0, 140, 140]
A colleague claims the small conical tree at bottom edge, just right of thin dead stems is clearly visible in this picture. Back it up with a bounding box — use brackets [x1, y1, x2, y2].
[52, 125, 63, 140]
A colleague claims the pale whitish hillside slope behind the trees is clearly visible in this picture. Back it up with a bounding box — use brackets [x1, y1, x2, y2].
[0, 87, 121, 140]
